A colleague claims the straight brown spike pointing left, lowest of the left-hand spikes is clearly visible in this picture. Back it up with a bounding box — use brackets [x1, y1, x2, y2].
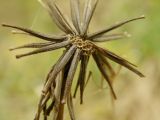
[16, 41, 71, 59]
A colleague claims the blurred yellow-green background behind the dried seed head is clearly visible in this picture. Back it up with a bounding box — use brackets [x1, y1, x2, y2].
[0, 0, 160, 120]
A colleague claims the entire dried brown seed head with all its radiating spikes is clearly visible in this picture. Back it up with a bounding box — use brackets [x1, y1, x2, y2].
[2, 0, 145, 120]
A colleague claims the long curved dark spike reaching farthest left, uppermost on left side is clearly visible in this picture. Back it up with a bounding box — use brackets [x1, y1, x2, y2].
[2, 24, 66, 42]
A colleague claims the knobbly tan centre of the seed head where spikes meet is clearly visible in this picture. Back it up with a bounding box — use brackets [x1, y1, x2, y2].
[71, 36, 95, 55]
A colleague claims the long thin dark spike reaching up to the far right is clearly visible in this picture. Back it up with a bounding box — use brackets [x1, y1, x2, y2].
[88, 16, 145, 39]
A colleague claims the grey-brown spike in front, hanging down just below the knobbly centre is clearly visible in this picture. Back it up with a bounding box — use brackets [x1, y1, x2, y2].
[61, 49, 81, 104]
